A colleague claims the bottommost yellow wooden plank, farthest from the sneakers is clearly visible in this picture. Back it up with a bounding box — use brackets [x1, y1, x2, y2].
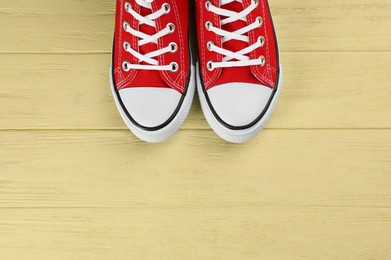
[0, 207, 391, 260]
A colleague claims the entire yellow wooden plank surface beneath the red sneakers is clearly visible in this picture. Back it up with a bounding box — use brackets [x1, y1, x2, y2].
[0, 0, 391, 260]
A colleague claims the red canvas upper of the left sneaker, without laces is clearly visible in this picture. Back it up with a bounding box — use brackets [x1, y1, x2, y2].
[113, 0, 189, 93]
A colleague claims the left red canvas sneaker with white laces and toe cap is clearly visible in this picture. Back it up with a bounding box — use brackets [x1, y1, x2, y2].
[110, 0, 195, 142]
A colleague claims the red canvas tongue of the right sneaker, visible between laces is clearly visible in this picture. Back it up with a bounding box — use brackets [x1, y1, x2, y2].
[215, 1, 259, 85]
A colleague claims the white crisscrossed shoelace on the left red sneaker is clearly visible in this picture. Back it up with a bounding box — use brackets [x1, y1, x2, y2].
[122, 0, 179, 72]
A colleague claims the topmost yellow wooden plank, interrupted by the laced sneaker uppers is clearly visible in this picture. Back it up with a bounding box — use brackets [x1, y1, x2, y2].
[0, 0, 391, 53]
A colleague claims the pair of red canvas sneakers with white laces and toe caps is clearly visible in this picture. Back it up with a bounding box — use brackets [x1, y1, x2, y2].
[110, 0, 282, 143]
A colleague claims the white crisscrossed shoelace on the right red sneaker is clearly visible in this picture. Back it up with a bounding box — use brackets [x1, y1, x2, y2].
[205, 0, 265, 71]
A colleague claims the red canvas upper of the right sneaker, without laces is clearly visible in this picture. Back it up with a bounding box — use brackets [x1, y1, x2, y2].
[196, 0, 279, 90]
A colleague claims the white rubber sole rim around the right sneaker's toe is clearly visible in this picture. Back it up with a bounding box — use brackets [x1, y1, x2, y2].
[197, 64, 283, 143]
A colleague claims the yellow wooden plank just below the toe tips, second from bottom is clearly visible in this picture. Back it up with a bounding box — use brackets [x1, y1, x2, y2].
[0, 130, 391, 208]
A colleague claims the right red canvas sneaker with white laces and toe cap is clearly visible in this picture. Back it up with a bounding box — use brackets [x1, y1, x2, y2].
[196, 0, 282, 143]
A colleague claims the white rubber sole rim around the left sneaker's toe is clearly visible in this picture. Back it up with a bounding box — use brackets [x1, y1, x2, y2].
[109, 65, 195, 143]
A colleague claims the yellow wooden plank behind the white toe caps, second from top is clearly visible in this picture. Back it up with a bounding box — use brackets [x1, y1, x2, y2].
[0, 52, 391, 129]
